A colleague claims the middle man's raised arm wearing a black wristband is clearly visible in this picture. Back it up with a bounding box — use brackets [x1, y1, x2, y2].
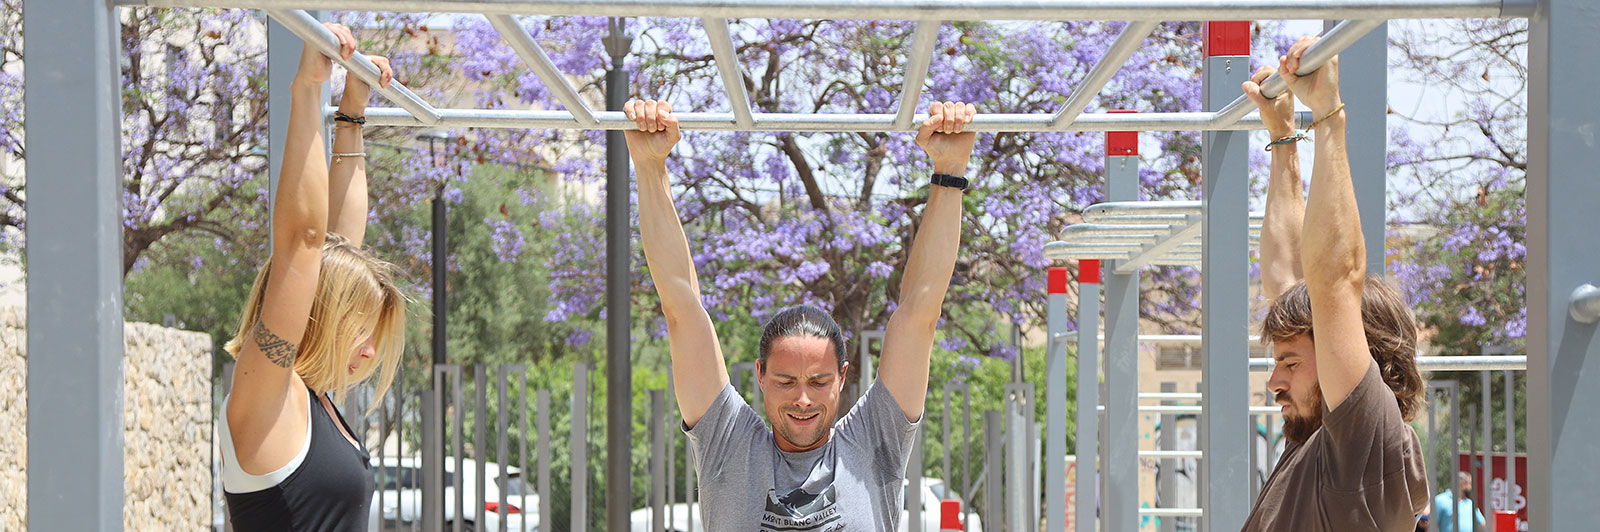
[878, 103, 976, 421]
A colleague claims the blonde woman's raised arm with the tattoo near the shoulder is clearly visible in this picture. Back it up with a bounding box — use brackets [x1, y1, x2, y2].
[227, 24, 355, 458]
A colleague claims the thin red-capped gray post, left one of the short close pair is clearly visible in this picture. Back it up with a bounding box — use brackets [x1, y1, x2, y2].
[1043, 268, 1067, 532]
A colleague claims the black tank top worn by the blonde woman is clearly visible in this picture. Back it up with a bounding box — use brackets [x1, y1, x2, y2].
[224, 389, 376, 532]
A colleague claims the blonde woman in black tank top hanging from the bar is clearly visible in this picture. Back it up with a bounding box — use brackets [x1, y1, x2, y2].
[218, 24, 405, 532]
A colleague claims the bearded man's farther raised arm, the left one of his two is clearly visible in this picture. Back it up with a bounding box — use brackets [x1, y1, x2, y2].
[1243, 66, 1306, 301]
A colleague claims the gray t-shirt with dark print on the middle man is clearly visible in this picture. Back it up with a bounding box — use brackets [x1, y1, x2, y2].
[685, 381, 920, 532]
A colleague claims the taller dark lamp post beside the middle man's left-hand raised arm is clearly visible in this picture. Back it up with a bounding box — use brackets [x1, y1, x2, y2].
[605, 18, 634, 532]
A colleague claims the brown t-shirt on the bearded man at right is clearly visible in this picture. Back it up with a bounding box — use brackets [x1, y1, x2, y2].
[1243, 361, 1429, 532]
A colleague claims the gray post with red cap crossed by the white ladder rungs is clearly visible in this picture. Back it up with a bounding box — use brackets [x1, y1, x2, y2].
[1101, 114, 1145, 530]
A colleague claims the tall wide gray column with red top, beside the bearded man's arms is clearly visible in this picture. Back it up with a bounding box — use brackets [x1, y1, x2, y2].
[1200, 21, 1251, 530]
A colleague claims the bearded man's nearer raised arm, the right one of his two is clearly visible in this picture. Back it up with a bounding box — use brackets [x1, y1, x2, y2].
[1278, 37, 1381, 410]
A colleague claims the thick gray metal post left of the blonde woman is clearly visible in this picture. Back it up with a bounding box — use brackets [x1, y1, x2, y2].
[23, 0, 123, 530]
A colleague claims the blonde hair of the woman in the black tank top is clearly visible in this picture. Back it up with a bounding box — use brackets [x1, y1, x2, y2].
[222, 232, 406, 413]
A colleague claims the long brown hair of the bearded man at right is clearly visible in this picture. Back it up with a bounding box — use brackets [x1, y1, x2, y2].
[1261, 277, 1426, 421]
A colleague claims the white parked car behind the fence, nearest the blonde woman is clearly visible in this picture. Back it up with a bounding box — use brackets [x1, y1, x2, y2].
[366, 457, 539, 532]
